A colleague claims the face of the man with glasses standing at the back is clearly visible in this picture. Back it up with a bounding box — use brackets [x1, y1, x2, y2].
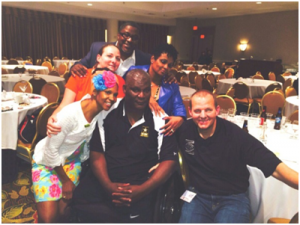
[118, 25, 139, 55]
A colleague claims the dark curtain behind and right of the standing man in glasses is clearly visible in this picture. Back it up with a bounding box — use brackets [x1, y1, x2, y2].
[119, 21, 169, 54]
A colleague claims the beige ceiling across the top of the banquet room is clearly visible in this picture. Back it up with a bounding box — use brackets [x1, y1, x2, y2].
[1, 1, 299, 24]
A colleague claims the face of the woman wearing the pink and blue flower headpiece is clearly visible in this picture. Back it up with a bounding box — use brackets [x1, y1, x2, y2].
[96, 84, 118, 111]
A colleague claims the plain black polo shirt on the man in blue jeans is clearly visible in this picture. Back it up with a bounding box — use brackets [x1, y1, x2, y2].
[177, 117, 281, 195]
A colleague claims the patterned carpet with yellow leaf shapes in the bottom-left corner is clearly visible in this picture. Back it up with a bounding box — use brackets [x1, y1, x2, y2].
[1, 165, 37, 224]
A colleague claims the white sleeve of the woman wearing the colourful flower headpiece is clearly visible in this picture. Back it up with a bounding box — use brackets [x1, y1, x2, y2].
[44, 110, 76, 168]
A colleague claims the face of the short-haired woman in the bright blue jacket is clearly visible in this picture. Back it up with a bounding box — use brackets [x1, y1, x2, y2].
[149, 53, 174, 76]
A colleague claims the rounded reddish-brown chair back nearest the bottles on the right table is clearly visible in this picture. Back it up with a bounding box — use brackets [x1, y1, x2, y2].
[261, 91, 285, 115]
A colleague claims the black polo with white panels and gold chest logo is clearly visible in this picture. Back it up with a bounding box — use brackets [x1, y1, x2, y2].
[90, 100, 178, 184]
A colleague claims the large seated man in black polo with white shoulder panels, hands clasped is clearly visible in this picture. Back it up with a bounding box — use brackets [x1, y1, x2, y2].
[74, 69, 178, 224]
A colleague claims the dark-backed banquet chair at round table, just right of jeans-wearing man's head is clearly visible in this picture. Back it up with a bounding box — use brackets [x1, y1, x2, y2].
[232, 82, 253, 114]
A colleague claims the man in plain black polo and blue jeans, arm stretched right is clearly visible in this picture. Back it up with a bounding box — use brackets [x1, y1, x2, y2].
[177, 90, 299, 224]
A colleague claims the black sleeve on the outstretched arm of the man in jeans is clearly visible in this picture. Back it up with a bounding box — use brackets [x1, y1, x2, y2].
[239, 131, 281, 177]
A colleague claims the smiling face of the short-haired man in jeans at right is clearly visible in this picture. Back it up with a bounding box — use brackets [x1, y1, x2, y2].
[189, 94, 220, 131]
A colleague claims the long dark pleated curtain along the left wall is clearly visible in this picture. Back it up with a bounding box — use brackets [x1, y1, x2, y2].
[1, 6, 106, 60]
